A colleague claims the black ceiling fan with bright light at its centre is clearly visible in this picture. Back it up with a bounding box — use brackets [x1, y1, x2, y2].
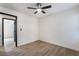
[27, 3, 52, 14]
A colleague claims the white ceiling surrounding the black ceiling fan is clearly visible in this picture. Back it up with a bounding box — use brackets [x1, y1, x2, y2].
[0, 3, 78, 18]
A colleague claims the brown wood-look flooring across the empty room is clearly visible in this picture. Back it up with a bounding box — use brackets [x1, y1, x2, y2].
[0, 41, 79, 56]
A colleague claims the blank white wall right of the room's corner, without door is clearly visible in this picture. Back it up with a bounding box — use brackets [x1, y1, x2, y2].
[39, 8, 79, 51]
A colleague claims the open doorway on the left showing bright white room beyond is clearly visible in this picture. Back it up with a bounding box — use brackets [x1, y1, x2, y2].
[2, 18, 17, 48]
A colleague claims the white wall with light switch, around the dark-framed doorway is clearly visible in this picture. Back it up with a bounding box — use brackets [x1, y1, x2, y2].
[0, 7, 38, 45]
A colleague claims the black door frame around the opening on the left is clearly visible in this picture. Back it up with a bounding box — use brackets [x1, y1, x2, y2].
[0, 12, 17, 47]
